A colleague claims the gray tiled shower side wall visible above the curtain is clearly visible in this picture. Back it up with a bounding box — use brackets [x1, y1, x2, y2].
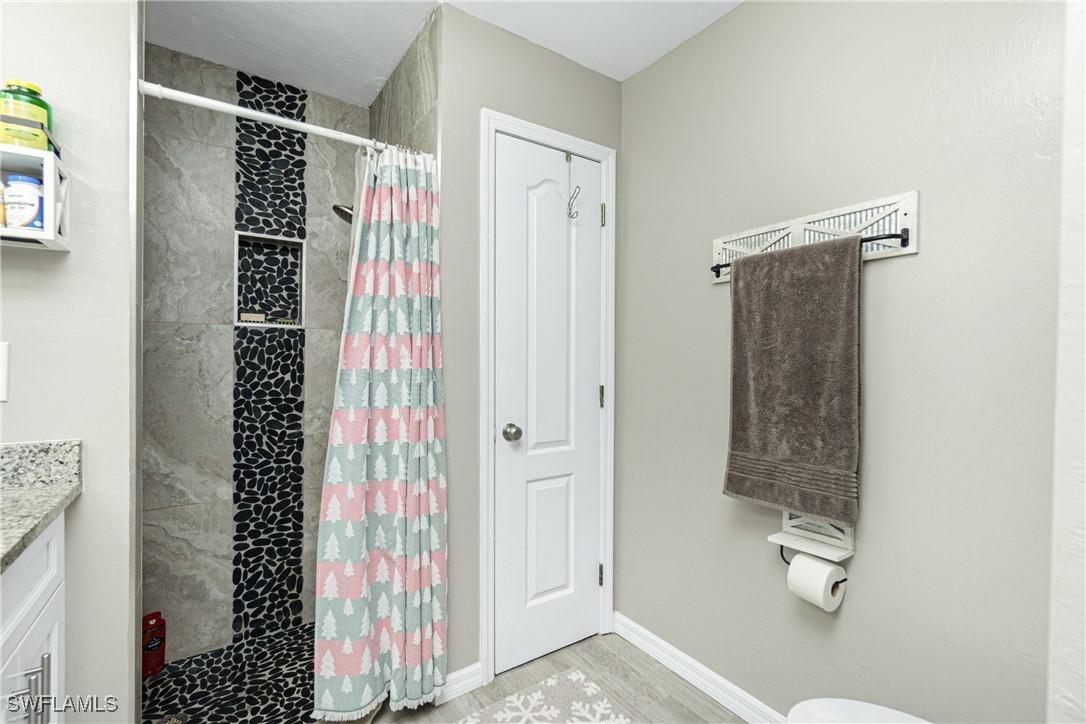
[369, 9, 442, 153]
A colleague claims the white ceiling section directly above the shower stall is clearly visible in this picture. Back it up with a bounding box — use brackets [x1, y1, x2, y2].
[146, 0, 437, 106]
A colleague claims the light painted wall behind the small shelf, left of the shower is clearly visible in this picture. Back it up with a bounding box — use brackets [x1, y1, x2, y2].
[0, 2, 142, 722]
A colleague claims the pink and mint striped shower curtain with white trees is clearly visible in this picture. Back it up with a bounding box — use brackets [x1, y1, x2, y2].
[313, 149, 446, 721]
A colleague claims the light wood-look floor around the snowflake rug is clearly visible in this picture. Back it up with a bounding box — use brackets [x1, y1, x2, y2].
[375, 634, 743, 724]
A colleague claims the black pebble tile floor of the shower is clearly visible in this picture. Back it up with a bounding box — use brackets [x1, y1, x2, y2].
[143, 623, 313, 724]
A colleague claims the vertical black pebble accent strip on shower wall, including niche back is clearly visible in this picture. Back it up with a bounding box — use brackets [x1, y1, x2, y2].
[227, 71, 307, 646]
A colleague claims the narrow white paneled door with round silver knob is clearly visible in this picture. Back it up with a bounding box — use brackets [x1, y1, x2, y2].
[494, 134, 605, 672]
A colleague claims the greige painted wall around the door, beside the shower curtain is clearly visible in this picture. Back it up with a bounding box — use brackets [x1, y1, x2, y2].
[439, 5, 620, 671]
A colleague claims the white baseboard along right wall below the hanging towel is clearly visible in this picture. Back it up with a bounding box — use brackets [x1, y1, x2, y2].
[615, 611, 785, 722]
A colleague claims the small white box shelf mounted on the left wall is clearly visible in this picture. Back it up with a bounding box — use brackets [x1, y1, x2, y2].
[0, 143, 70, 252]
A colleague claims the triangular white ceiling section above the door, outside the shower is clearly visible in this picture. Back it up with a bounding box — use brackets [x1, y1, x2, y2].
[451, 0, 740, 80]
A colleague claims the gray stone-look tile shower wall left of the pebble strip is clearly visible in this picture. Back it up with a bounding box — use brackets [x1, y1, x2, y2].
[142, 45, 237, 660]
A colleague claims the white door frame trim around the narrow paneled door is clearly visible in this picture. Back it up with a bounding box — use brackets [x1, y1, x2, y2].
[479, 109, 616, 686]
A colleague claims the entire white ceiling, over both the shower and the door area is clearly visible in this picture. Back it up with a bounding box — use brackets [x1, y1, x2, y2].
[147, 0, 740, 106]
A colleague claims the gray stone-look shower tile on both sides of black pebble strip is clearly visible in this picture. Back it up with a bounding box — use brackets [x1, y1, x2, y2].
[142, 45, 369, 660]
